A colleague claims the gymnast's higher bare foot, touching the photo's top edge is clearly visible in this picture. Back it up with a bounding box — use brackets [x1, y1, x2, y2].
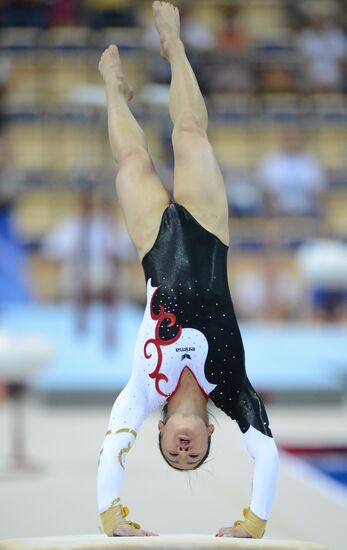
[153, 1, 180, 60]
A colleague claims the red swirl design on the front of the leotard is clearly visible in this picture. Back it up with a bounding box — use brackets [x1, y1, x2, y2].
[143, 286, 182, 397]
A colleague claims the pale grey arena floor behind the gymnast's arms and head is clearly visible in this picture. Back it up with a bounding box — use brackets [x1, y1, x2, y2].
[0, 401, 347, 550]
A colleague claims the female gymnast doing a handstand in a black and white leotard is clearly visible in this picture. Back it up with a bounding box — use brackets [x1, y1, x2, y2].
[98, 2, 278, 538]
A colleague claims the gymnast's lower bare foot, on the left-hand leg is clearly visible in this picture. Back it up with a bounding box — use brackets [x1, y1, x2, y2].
[99, 44, 134, 101]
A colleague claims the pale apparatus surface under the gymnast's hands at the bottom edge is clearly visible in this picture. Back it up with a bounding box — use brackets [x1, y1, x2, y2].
[0, 535, 329, 550]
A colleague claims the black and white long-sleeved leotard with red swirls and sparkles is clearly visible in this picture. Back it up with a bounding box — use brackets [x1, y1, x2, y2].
[98, 203, 278, 519]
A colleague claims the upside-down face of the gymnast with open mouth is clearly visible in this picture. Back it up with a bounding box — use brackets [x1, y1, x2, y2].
[158, 413, 214, 470]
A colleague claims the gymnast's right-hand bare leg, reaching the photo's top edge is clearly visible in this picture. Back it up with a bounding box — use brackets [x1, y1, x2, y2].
[153, 2, 229, 244]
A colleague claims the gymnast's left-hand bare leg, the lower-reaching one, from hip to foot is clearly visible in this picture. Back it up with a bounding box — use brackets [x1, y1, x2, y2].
[99, 45, 170, 259]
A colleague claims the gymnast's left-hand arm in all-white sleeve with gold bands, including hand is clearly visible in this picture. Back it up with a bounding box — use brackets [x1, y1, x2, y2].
[97, 375, 151, 536]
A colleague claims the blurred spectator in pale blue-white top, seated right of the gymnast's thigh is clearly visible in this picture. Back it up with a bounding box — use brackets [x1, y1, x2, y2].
[257, 127, 327, 216]
